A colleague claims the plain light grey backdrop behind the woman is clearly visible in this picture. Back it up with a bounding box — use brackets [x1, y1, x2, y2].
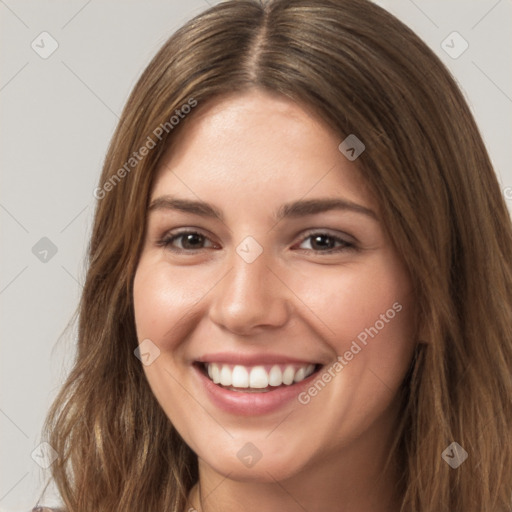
[0, 0, 512, 512]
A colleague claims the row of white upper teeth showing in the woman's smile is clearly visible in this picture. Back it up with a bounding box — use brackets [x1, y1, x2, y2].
[205, 363, 315, 389]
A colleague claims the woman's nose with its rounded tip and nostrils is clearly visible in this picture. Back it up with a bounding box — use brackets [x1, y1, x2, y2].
[210, 248, 293, 335]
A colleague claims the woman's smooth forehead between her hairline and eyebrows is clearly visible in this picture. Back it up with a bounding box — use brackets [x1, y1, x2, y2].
[152, 90, 374, 212]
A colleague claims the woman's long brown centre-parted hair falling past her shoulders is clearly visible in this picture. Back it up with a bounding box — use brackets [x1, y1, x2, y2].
[39, 0, 512, 512]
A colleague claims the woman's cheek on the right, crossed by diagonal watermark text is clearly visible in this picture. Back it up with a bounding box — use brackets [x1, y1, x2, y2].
[286, 255, 415, 445]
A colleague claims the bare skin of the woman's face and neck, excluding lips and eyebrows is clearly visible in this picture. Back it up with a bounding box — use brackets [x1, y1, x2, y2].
[134, 89, 415, 512]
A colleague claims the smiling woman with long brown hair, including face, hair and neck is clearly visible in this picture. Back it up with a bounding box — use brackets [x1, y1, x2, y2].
[35, 0, 512, 512]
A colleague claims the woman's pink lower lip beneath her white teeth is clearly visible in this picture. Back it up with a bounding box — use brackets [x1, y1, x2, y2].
[193, 365, 318, 416]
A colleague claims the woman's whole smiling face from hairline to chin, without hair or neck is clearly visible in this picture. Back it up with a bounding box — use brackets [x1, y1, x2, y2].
[134, 90, 414, 481]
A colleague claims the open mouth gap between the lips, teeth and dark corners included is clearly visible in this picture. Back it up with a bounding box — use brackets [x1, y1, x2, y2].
[194, 362, 322, 393]
